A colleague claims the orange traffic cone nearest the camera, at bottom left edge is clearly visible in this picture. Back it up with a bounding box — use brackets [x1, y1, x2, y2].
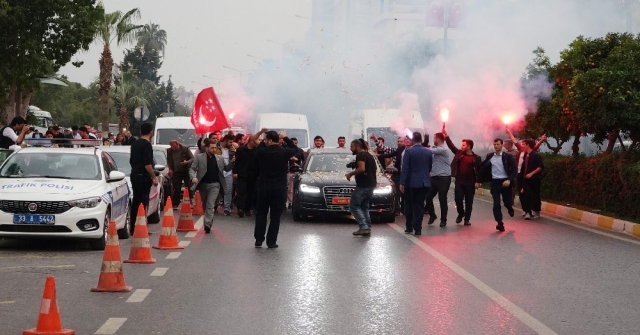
[22, 276, 76, 335]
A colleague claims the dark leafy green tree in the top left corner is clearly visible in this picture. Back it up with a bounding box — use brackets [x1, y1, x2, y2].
[0, 0, 103, 123]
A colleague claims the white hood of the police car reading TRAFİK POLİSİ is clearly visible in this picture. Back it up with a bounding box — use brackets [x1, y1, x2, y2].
[0, 178, 102, 195]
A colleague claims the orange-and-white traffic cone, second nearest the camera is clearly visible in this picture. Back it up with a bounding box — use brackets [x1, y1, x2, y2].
[91, 220, 131, 292]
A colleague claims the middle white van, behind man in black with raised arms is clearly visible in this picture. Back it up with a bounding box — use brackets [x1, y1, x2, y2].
[254, 113, 309, 150]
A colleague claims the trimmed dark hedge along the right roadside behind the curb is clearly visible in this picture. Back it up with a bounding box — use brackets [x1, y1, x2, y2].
[541, 154, 640, 222]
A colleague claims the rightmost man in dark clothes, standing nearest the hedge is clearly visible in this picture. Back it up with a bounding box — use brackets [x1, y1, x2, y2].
[518, 139, 544, 220]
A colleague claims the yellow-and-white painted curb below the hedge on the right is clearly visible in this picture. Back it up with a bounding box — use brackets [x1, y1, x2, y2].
[476, 188, 640, 237]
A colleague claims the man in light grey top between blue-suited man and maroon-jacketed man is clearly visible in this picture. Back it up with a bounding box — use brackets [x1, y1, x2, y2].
[428, 133, 451, 227]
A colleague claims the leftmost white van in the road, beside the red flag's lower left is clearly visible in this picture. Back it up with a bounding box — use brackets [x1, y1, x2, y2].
[151, 116, 200, 151]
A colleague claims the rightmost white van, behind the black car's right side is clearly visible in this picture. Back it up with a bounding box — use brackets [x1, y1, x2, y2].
[349, 109, 424, 148]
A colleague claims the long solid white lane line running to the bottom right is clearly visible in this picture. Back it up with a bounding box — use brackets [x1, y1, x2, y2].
[389, 223, 557, 335]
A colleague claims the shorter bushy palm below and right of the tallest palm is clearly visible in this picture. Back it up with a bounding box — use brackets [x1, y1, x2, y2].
[112, 69, 156, 132]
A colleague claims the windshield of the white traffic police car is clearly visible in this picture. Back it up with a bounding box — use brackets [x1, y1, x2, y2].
[0, 152, 102, 180]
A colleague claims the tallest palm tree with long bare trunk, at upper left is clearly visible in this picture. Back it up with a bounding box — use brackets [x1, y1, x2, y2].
[95, 1, 142, 134]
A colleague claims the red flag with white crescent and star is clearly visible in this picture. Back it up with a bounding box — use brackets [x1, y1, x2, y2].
[191, 87, 229, 134]
